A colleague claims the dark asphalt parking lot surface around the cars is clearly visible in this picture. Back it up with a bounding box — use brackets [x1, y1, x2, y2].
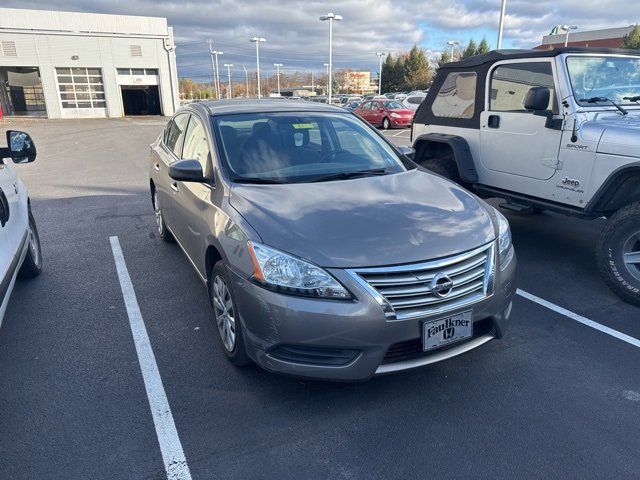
[0, 118, 640, 479]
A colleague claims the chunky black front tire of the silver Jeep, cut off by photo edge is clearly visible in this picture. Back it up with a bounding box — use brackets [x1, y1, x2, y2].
[596, 202, 640, 306]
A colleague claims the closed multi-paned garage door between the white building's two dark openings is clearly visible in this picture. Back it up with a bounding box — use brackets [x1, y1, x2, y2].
[56, 68, 107, 108]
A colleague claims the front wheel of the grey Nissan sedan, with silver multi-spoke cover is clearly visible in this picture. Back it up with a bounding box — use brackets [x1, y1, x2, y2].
[209, 260, 252, 367]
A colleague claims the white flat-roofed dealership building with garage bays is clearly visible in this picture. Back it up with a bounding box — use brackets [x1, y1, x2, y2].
[0, 8, 179, 118]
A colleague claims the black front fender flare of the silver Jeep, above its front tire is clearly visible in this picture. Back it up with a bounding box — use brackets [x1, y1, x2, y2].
[585, 166, 640, 215]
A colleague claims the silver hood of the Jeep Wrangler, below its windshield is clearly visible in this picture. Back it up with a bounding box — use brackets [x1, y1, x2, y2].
[584, 113, 640, 157]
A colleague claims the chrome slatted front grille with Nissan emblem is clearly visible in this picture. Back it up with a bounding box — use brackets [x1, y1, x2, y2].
[350, 243, 494, 320]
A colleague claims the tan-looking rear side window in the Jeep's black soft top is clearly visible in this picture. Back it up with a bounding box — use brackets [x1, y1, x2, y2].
[431, 72, 476, 118]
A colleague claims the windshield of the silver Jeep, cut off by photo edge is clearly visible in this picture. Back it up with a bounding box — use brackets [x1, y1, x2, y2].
[567, 56, 640, 106]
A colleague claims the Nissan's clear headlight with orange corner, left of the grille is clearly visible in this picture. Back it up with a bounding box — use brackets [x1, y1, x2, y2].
[247, 241, 351, 299]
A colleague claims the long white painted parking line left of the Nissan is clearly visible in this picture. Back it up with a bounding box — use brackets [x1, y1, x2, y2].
[109, 237, 191, 480]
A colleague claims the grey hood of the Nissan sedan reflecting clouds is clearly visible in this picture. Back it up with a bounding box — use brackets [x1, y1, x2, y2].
[230, 169, 495, 268]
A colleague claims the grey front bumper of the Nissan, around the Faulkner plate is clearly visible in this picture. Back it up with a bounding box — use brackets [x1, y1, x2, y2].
[232, 251, 516, 381]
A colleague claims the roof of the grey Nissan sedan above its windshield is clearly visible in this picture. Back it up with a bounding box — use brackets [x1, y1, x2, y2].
[185, 98, 344, 116]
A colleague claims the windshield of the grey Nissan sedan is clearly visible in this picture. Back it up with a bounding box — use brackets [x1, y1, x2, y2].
[214, 113, 407, 183]
